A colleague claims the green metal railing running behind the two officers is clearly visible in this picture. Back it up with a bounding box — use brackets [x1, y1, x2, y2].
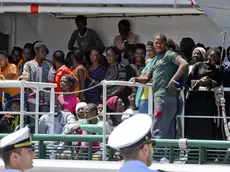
[0, 134, 230, 164]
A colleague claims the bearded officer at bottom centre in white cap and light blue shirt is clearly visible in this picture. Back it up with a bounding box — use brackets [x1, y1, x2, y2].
[108, 114, 157, 172]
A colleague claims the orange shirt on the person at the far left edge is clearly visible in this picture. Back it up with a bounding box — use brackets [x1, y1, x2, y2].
[0, 64, 20, 97]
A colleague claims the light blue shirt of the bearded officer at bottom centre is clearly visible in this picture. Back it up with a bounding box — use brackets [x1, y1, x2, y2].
[118, 160, 158, 172]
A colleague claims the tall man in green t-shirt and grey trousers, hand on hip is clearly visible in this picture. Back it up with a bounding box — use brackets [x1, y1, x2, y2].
[131, 34, 188, 139]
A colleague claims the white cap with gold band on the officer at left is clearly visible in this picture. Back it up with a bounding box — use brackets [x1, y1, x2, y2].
[0, 127, 32, 151]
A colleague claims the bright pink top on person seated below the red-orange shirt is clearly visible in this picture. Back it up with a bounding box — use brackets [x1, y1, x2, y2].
[57, 94, 80, 114]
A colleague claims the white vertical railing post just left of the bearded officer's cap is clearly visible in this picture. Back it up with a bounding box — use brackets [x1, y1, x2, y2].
[102, 81, 107, 161]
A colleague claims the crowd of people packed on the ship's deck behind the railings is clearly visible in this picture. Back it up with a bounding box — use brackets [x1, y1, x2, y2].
[0, 16, 230, 145]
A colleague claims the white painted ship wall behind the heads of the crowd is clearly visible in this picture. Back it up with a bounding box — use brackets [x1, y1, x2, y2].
[0, 14, 230, 56]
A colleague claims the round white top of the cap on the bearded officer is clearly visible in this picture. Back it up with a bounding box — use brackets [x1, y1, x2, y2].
[108, 114, 152, 149]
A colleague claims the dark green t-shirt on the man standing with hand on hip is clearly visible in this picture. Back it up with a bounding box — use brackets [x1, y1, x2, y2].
[149, 51, 181, 97]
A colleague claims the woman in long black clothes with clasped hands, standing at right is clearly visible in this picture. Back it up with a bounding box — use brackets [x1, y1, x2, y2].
[185, 48, 220, 140]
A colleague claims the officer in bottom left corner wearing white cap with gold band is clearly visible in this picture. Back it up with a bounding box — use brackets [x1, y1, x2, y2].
[0, 127, 35, 172]
